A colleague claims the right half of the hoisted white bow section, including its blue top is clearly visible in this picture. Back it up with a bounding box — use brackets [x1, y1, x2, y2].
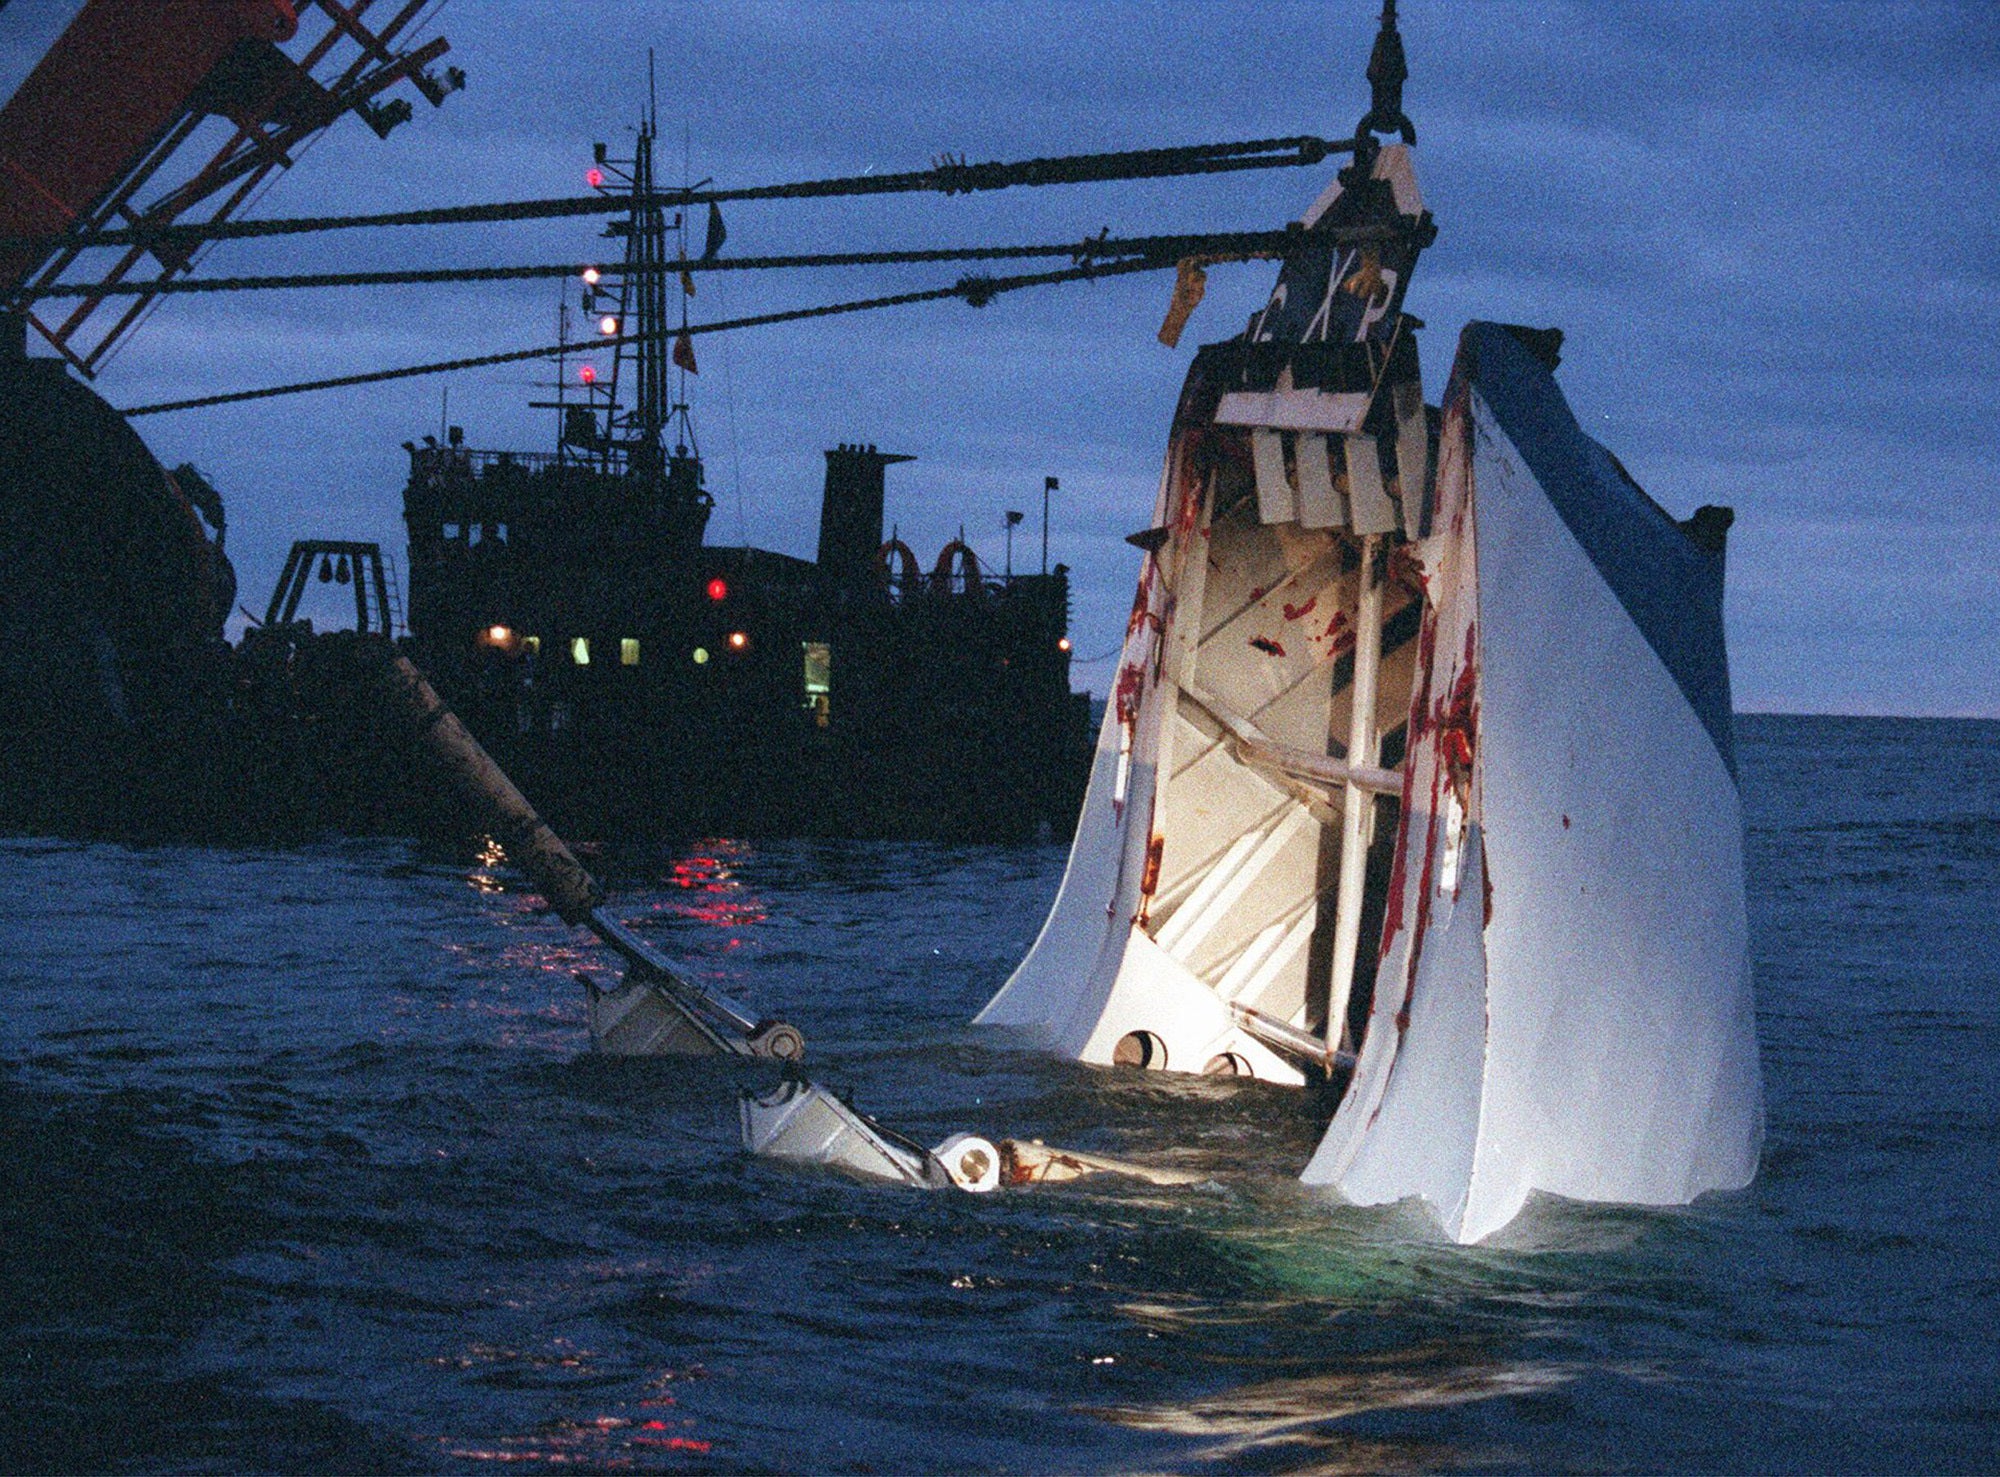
[1304, 324, 1762, 1241]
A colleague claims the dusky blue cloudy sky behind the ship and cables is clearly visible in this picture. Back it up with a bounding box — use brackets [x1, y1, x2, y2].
[0, 0, 2000, 714]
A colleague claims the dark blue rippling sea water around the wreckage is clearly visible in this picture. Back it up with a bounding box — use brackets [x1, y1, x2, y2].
[0, 718, 2000, 1471]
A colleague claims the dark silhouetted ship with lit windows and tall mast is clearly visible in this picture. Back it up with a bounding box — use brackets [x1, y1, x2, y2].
[404, 116, 1088, 839]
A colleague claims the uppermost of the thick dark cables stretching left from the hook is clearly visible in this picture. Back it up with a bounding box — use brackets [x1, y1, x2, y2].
[0, 134, 1356, 248]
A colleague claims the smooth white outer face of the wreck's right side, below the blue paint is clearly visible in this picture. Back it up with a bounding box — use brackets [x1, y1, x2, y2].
[1460, 394, 1762, 1241]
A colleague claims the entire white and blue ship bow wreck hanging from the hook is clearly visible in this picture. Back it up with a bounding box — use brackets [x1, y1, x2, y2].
[978, 146, 1762, 1241]
